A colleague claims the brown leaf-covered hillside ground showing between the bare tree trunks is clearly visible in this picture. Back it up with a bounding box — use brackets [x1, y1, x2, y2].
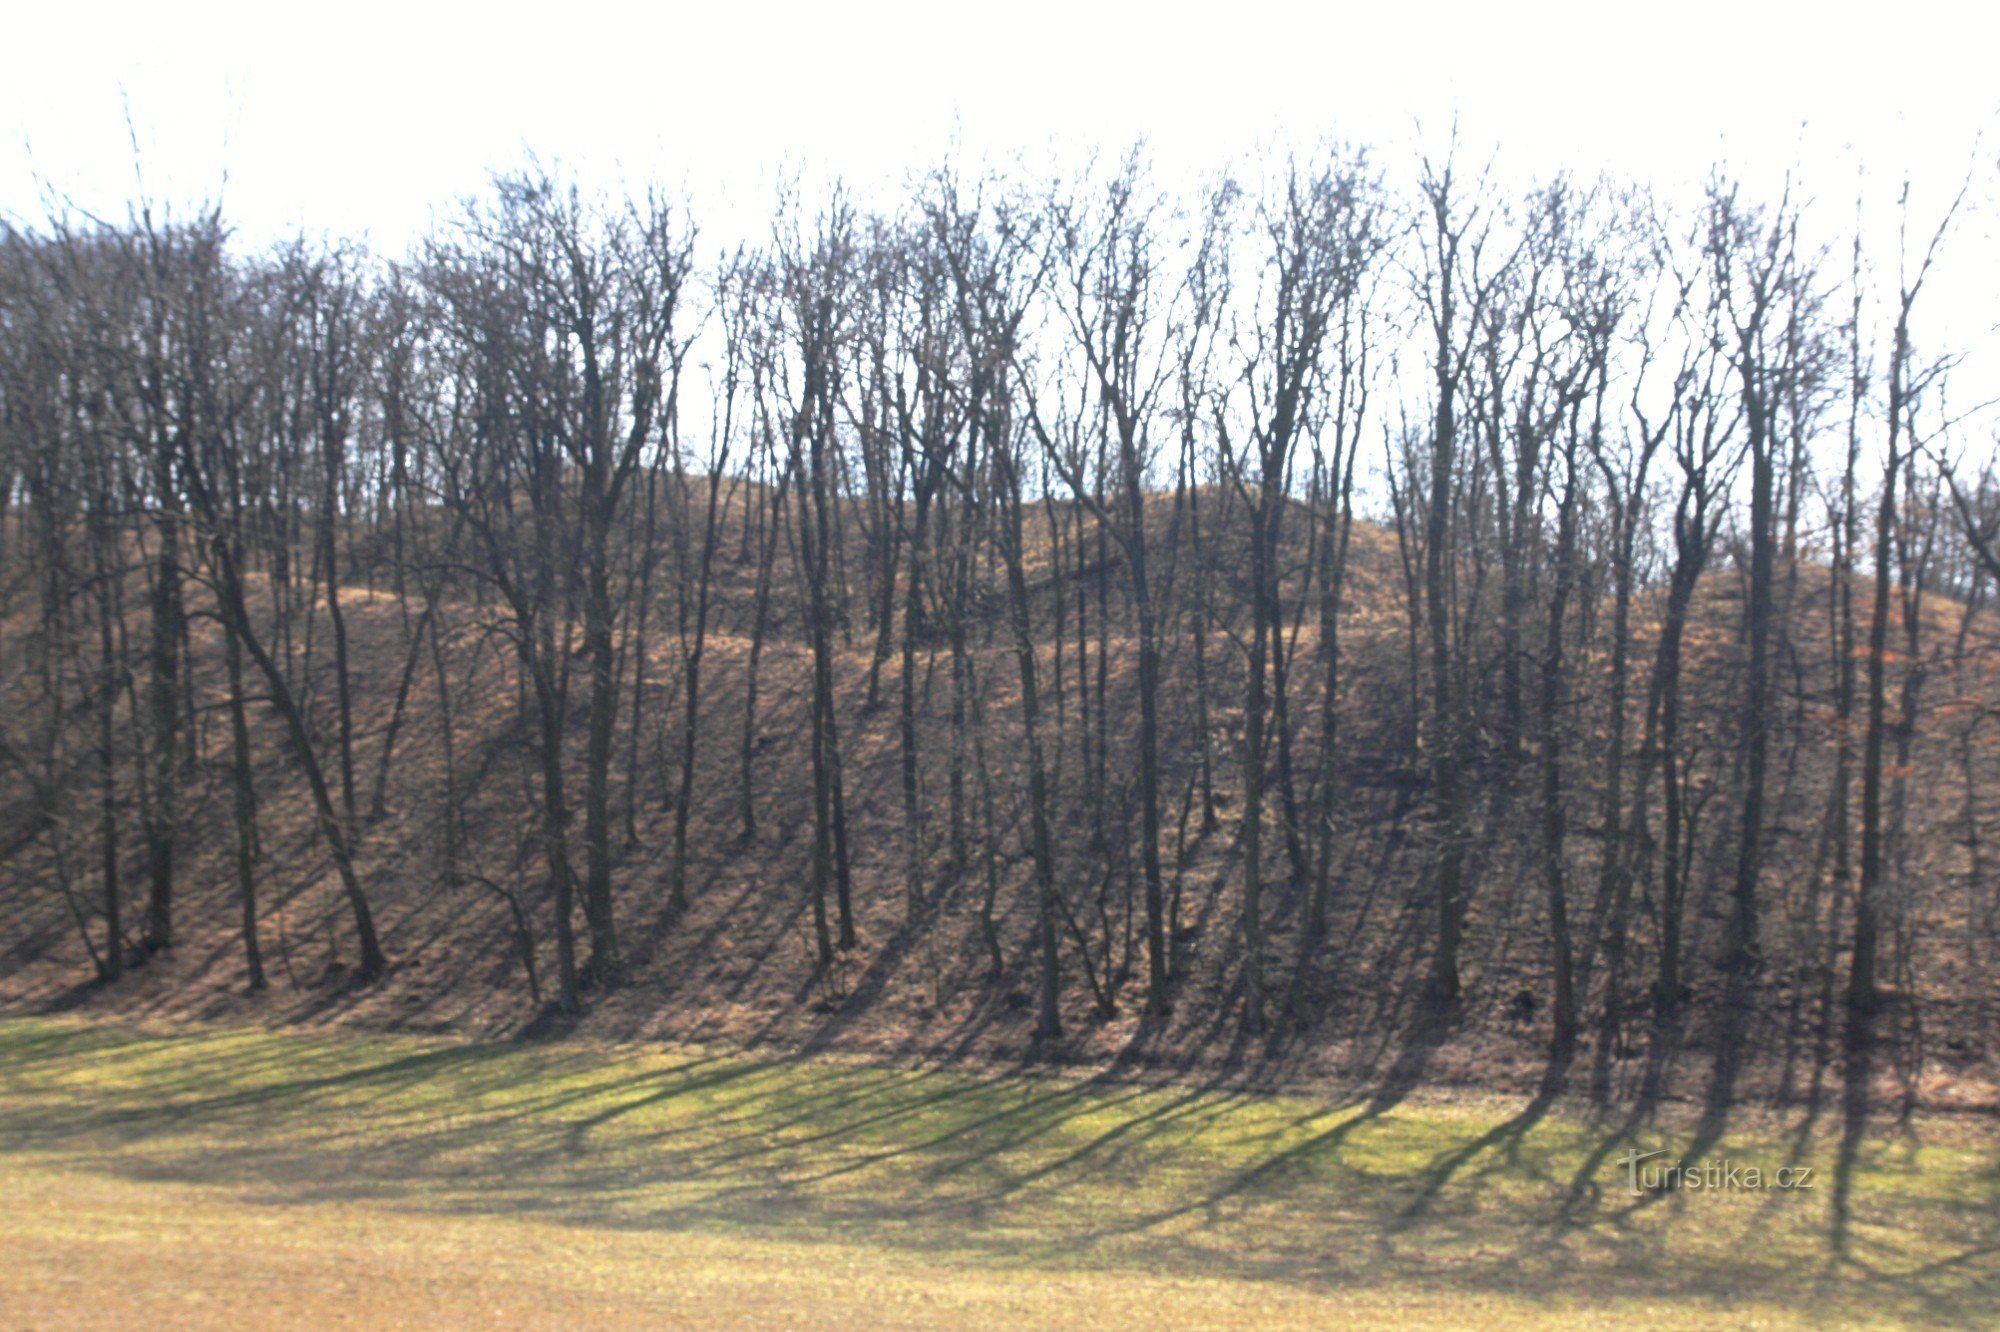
[15, 508, 2000, 1126]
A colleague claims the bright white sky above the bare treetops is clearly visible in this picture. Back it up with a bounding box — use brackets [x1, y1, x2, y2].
[0, 0, 2000, 248]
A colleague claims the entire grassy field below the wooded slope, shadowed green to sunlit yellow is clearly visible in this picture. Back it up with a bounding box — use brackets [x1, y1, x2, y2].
[0, 1018, 2000, 1328]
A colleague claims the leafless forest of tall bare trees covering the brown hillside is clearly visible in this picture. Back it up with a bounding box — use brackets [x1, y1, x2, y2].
[0, 150, 2000, 1106]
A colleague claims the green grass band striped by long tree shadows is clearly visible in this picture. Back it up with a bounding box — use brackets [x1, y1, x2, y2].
[0, 1010, 2000, 1324]
